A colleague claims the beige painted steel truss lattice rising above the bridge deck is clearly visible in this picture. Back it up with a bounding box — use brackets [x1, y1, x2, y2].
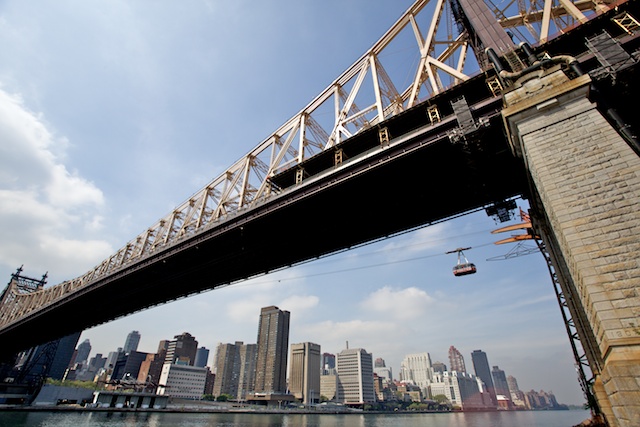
[0, 0, 608, 327]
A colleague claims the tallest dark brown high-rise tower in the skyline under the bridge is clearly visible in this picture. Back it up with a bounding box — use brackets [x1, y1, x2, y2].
[254, 306, 290, 393]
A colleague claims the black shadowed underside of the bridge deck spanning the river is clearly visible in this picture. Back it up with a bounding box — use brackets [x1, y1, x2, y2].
[0, 76, 528, 358]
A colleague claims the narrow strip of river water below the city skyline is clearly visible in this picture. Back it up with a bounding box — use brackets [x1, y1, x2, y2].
[0, 410, 589, 427]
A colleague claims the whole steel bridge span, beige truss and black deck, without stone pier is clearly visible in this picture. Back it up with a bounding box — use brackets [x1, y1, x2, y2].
[0, 0, 640, 422]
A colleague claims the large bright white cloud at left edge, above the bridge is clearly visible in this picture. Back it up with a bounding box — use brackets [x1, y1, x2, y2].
[0, 90, 112, 278]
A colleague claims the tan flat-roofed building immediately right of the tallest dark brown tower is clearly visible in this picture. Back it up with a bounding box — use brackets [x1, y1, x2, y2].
[289, 342, 321, 405]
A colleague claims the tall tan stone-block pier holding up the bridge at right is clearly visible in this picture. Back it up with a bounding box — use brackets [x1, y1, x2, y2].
[503, 67, 640, 427]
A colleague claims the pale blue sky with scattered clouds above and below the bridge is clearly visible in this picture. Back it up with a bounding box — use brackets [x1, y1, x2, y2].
[0, 0, 583, 404]
